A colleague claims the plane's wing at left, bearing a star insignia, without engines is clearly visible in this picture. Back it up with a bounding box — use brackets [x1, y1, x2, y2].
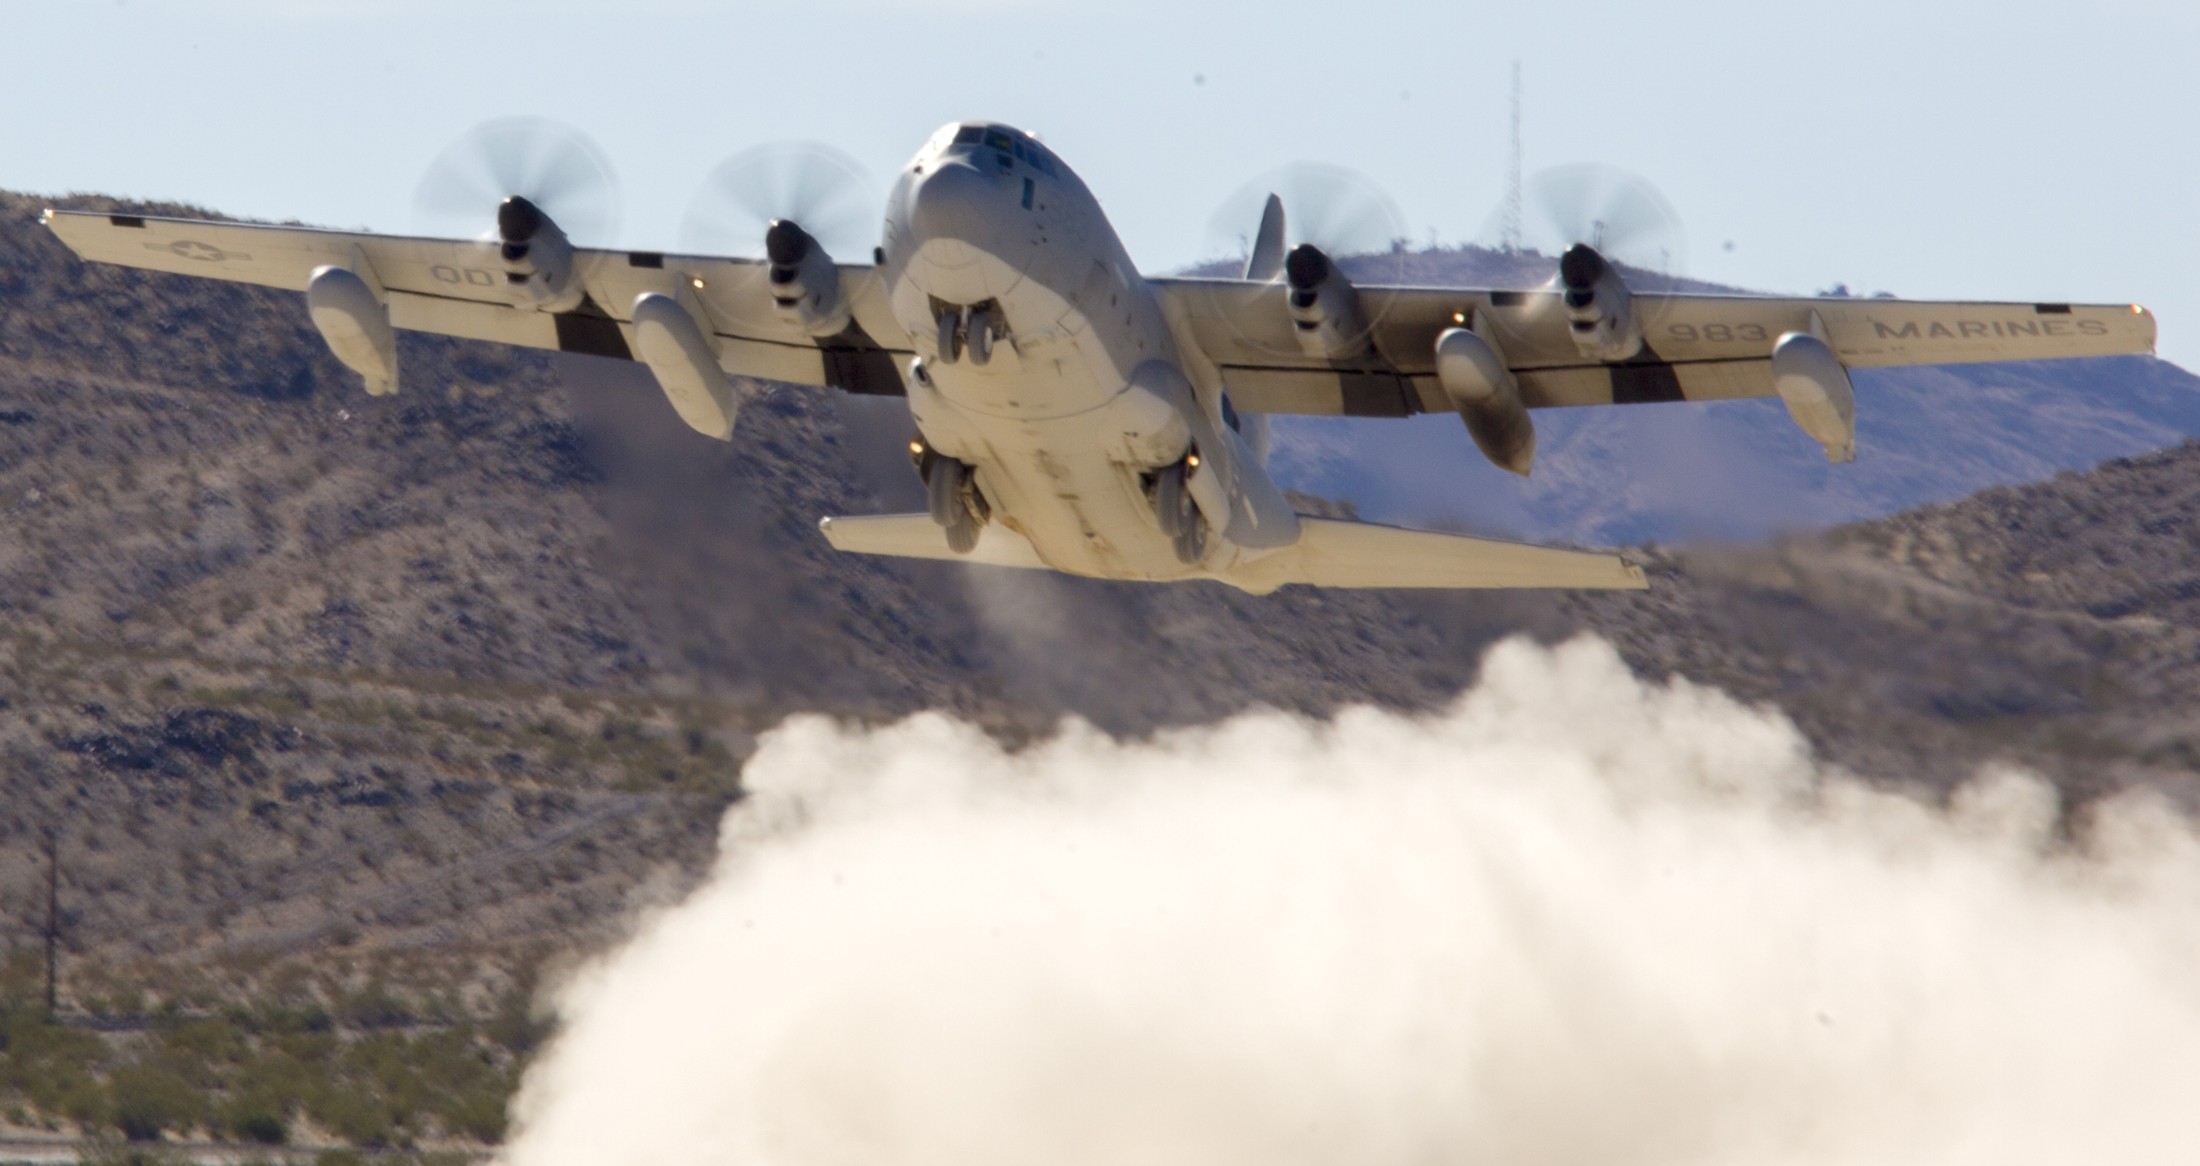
[46, 211, 904, 396]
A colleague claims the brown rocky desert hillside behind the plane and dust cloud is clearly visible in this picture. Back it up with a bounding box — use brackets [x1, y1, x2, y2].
[0, 183, 2200, 999]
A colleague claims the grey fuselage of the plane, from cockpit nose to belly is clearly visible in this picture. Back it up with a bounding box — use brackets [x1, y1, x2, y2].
[880, 123, 1296, 579]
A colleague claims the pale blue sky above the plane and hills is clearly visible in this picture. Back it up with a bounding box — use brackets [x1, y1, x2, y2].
[17, 0, 2200, 363]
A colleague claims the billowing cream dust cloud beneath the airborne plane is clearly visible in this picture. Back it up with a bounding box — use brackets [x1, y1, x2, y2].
[504, 640, 2200, 1166]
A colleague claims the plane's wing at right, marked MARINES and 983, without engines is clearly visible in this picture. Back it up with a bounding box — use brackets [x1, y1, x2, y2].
[1153, 279, 2154, 416]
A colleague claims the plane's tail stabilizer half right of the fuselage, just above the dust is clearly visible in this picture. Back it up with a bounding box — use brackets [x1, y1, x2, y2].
[1221, 517, 1650, 592]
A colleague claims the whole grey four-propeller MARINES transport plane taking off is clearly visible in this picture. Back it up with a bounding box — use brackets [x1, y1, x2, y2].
[46, 123, 2154, 592]
